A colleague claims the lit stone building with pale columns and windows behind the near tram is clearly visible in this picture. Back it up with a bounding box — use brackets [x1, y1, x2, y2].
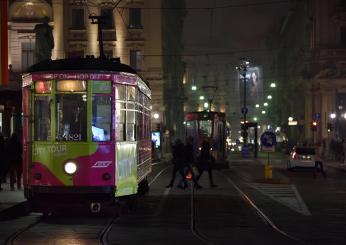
[0, 0, 164, 138]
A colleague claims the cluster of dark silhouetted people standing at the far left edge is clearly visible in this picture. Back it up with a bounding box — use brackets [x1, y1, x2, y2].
[0, 133, 22, 191]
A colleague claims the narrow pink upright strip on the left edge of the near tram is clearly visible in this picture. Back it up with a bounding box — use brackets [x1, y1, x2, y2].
[22, 87, 33, 186]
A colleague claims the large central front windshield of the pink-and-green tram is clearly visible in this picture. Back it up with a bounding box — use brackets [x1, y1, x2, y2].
[56, 94, 87, 141]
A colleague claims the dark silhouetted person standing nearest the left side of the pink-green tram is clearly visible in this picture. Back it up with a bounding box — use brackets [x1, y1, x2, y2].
[6, 133, 22, 191]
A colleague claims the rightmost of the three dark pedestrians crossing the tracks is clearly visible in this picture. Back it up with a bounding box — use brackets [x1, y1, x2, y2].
[197, 140, 216, 187]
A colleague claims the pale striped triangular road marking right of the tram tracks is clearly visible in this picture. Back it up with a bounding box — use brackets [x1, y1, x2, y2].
[248, 183, 311, 216]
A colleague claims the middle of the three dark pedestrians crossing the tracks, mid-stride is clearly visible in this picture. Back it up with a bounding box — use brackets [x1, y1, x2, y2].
[179, 136, 202, 189]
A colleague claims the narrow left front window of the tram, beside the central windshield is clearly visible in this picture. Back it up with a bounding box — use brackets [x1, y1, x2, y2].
[34, 96, 51, 141]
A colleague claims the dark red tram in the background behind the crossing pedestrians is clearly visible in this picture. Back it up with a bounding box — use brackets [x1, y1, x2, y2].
[185, 111, 227, 163]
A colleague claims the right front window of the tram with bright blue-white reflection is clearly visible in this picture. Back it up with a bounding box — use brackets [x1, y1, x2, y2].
[91, 96, 112, 141]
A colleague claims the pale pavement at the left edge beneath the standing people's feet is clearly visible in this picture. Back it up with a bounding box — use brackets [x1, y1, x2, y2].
[0, 183, 26, 212]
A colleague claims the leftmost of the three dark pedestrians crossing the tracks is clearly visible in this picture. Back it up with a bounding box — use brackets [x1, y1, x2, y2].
[166, 139, 187, 188]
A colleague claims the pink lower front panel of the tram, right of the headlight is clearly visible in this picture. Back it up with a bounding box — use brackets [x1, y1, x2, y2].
[73, 144, 115, 186]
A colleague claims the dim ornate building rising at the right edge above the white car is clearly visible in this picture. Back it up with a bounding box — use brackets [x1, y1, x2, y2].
[277, 0, 346, 144]
